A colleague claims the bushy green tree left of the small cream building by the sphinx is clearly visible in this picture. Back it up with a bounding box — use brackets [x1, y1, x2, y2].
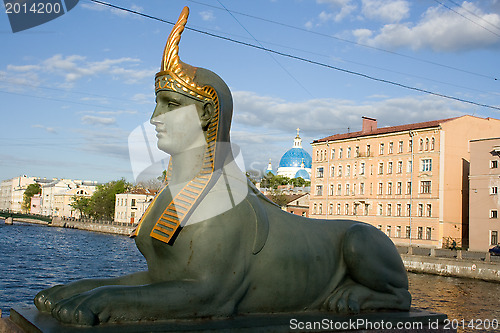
[90, 178, 131, 220]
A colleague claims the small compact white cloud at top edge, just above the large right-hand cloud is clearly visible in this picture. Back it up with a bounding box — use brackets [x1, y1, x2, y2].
[361, 0, 410, 23]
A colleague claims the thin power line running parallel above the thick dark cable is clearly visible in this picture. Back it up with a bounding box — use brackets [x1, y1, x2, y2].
[186, 0, 497, 81]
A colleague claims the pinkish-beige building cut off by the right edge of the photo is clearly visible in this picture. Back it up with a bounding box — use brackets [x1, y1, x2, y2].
[469, 137, 500, 251]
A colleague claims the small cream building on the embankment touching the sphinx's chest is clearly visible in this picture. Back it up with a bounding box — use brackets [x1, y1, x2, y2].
[115, 188, 156, 223]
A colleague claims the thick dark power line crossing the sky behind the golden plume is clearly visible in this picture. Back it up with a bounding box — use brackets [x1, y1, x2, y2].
[90, 0, 500, 111]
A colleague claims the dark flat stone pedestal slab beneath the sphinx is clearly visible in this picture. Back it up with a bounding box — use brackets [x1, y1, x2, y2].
[10, 308, 456, 333]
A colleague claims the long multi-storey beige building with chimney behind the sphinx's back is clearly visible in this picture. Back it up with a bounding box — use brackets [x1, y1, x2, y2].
[309, 115, 500, 248]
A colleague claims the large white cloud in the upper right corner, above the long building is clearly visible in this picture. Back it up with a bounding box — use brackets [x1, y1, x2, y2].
[354, 2, 500, 52]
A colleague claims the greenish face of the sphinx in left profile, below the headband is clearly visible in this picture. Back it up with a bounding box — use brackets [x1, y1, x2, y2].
[150, 91, 207, 155]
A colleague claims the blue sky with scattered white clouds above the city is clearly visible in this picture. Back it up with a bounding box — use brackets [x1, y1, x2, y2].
[0, 0, 500, 182]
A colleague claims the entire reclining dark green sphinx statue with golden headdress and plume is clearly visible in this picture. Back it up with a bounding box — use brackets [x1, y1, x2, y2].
[34, 7, 411, 325]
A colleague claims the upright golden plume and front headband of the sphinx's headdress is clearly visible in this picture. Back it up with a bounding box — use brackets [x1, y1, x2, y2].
[155, 7, 214, 101]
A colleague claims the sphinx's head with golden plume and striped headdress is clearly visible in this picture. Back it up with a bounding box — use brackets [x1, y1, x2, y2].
[151, 7, 233, 154]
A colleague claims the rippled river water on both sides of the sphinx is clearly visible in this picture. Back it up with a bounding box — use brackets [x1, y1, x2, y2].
[0, 220, 500, 332]
